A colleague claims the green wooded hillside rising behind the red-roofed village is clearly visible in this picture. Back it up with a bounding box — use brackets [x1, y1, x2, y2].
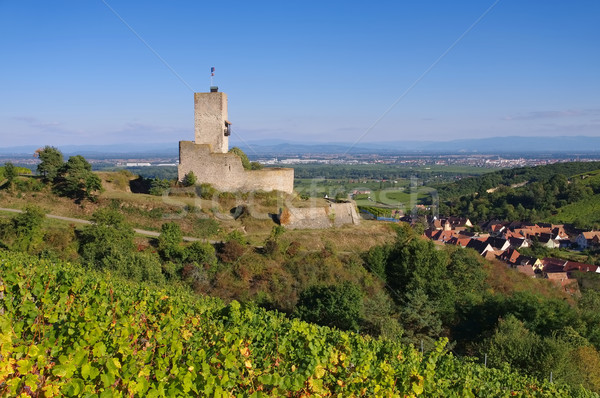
[437, 162, 600, 225]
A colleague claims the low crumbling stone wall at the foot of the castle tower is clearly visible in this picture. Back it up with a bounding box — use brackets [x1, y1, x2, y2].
[177, 141, 294, 193]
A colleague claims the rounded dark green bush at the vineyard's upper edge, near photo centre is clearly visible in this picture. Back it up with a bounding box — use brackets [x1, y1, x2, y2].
[295, 282, 363, 330]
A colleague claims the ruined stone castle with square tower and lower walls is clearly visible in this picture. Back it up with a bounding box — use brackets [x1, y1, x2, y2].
[177, 87, 294, 193]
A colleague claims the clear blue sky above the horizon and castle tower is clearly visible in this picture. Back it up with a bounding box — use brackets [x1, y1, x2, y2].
[0, 0, 600, 146]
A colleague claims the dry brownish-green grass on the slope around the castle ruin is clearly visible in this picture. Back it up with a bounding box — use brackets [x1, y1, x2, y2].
[0, 172, 393, 246]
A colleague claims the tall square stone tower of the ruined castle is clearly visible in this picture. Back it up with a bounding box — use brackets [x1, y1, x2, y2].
[194, 87, 231, 153]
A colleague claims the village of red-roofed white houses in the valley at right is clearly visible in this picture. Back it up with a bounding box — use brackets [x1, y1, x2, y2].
[420, 216, 600, 294]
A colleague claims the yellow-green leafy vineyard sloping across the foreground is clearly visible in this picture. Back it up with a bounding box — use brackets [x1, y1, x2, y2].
[0, 251, 597, 397]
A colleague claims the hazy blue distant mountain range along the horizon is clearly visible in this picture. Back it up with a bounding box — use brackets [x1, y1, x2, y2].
[0, 136, 600, 157]
